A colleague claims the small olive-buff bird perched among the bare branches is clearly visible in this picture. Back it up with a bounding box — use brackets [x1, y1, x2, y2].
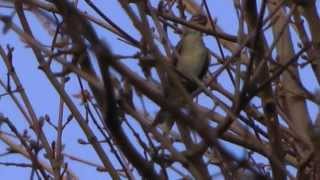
[153, 15, 210, 133]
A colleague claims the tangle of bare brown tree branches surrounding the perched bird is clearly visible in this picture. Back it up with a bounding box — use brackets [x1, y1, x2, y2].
[0, 0, 320, 180]
